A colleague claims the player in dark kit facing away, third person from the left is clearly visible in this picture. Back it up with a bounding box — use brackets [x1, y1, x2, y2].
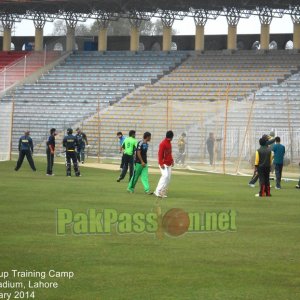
[63, 128, 80, 177]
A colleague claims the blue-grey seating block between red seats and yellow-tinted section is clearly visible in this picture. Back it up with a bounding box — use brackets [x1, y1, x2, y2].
[2, 52, 187, 150]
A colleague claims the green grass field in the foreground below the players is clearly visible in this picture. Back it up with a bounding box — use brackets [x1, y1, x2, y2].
[0, 160, 300, 300]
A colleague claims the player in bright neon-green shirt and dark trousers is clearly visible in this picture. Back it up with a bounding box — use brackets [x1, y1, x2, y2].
[117, 130, 137, 182]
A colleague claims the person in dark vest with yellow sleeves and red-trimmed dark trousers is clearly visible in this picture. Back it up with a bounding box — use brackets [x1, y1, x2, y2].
[255, 138, 273, 197]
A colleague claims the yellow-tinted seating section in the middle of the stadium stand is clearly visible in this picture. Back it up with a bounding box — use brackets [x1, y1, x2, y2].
[79, 51, 300, 157]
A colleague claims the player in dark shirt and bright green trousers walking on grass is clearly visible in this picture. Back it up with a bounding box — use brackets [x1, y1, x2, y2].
[127, 132, 151, 194]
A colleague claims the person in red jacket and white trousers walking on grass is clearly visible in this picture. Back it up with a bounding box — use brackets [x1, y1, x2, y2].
[154, 130, 174, 198]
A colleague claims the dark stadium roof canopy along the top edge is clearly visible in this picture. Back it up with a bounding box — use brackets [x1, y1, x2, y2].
[0, 0, 299, 14]
